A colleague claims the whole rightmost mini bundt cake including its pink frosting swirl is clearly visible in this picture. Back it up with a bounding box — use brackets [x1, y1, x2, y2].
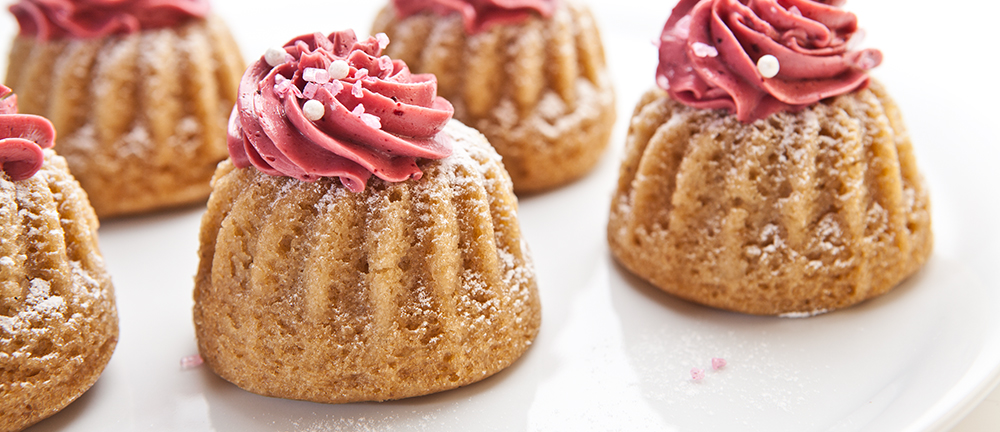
[608, 0, 933, 316]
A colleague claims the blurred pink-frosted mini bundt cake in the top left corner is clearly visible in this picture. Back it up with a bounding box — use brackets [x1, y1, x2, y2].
[7, 0, 245, 218]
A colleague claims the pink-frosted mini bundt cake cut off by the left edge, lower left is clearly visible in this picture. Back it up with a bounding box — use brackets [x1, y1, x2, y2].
[0, 86, 118, 431]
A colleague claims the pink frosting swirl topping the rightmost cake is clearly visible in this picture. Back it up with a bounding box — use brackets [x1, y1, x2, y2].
[656, 0, 882, 123]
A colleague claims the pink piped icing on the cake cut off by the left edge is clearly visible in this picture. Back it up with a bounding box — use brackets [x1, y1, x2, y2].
[0, 84, 56, 181]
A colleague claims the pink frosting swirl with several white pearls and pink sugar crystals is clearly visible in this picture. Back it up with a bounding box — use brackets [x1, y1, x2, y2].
[228, 30, 454, 192]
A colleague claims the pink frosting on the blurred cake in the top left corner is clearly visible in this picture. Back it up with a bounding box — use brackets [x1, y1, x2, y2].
[10, 0, 209, 40]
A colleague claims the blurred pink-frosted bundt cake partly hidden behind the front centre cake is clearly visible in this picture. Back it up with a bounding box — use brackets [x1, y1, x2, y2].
[372, 0, 615, 193]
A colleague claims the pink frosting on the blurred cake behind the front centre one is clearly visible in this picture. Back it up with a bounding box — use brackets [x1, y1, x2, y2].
[392, 0, 557, 34]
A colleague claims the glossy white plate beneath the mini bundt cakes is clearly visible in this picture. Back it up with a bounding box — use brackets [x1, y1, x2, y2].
[7, 0, 1000, 431]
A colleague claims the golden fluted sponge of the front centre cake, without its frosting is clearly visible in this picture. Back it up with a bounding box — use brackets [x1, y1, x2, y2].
[194, 123, 541, 403]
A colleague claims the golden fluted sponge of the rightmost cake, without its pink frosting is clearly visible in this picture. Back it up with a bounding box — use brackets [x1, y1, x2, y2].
[608, 84, 933, 315]
